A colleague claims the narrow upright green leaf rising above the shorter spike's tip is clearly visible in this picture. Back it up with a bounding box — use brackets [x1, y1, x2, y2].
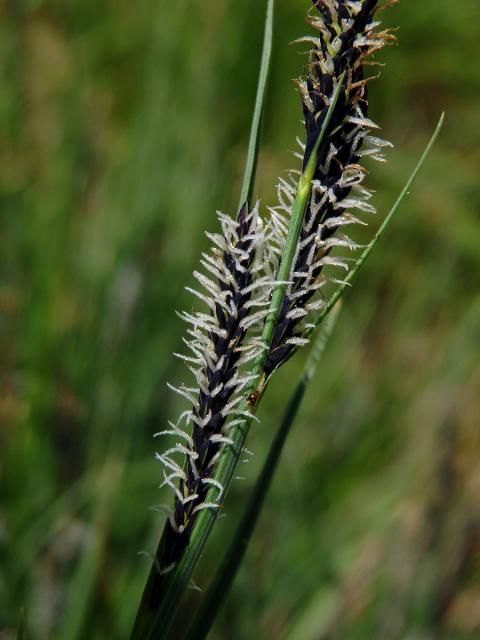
[238, 0, 275, 209]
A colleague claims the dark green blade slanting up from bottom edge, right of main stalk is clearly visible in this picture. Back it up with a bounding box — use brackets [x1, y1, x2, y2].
[187, 302, 340, 640]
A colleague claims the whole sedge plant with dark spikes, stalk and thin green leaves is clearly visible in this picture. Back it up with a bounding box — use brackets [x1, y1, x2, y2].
[132, 0, 438, 640]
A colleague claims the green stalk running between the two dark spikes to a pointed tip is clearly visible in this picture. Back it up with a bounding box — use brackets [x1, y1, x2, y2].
[131, 67, 344, 640]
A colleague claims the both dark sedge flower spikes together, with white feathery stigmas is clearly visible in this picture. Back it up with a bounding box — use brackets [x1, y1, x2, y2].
[157, 0, 393, 572]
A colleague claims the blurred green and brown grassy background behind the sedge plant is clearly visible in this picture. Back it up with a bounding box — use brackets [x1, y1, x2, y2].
[0, 0, 480, 640]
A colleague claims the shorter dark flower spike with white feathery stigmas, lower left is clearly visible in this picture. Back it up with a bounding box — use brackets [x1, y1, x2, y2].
[156, 205, 273, 572]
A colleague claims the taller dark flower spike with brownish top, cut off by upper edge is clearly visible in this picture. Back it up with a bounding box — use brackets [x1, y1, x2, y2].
[265, 0, 394, 376]
